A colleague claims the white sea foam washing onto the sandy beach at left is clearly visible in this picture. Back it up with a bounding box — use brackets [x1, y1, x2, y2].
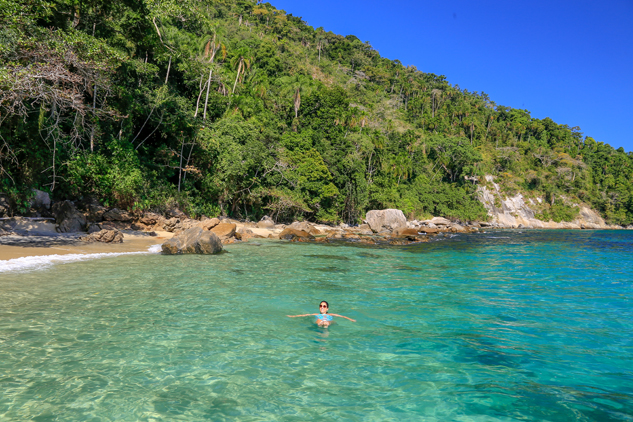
[0, 245, 161, 273]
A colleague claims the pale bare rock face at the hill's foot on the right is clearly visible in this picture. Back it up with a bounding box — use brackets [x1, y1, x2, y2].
[477, 175, 622, 229]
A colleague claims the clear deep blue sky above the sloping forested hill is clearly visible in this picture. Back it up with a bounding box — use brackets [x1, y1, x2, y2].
[270, 0, 633, 152]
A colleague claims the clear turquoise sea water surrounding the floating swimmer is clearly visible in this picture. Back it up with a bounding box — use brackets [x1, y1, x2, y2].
[0, 231, 633, 421]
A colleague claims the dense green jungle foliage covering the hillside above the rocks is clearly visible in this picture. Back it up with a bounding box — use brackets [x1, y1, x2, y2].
[0, 0, 633, 224]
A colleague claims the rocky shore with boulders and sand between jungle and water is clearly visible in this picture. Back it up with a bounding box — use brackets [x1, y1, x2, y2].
[0, 189, 633, 260]
